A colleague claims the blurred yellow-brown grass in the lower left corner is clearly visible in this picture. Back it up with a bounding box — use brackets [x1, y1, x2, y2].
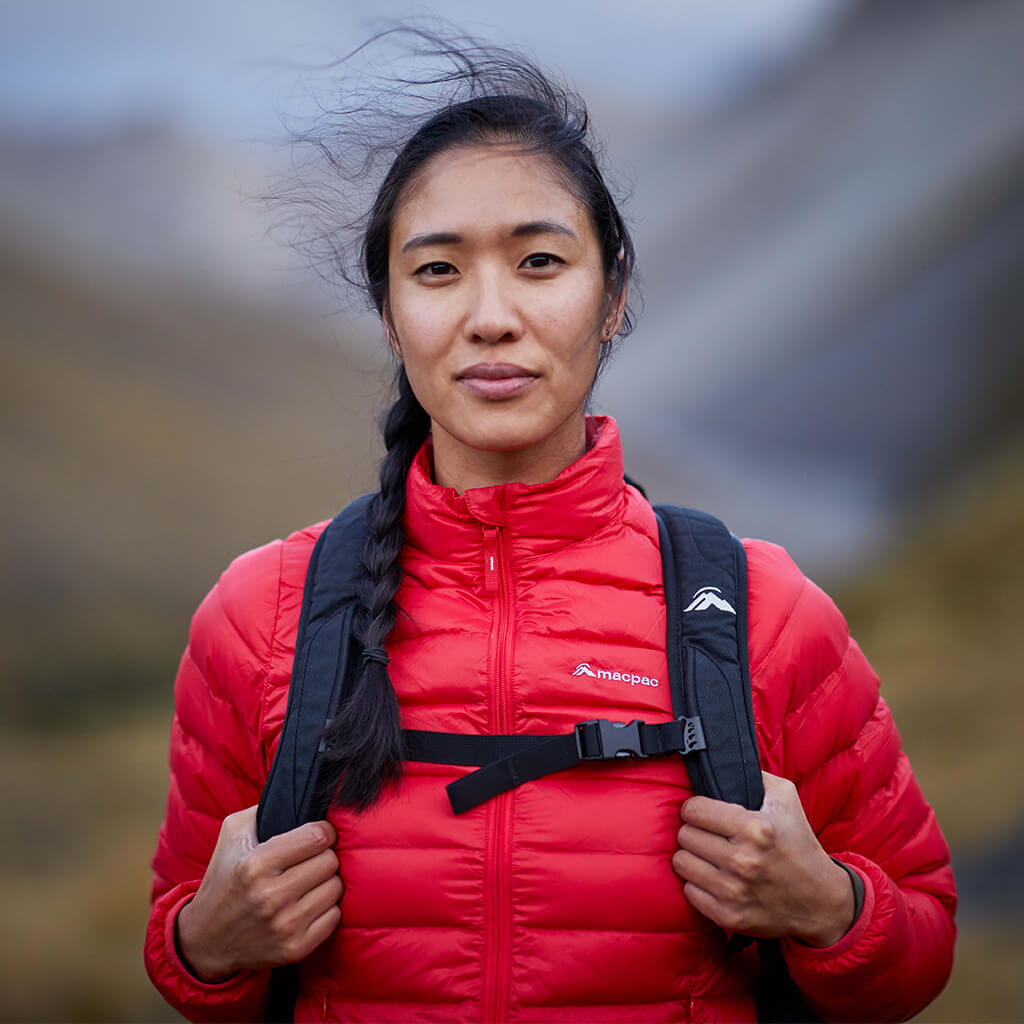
[0, 707, 180, 1021]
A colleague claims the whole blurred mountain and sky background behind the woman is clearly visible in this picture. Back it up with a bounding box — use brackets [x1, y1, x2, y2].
[0, 0, 1024, 1021]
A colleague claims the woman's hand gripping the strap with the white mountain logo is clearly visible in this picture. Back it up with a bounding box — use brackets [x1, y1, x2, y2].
[672, 772, 854, 946]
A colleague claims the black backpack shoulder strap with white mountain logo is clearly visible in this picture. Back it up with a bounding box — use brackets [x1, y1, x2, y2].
[654, 505, 764, 810]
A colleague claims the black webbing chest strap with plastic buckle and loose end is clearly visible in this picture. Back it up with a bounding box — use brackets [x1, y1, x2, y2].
[402, 718, 706, 814]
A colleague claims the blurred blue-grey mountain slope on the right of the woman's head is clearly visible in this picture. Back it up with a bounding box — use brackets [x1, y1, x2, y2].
[601, 2, 1024, 575]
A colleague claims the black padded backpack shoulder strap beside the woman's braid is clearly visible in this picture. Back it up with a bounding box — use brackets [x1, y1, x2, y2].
[256, 495, 373, 843]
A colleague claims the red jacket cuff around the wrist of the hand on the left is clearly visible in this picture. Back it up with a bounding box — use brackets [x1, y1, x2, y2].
[145, 881, 270, 1022]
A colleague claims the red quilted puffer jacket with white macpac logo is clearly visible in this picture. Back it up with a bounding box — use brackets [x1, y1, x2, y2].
[145, 420, 955, 1024]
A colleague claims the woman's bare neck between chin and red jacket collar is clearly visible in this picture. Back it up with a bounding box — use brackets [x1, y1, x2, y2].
[431, 416, 587, 495]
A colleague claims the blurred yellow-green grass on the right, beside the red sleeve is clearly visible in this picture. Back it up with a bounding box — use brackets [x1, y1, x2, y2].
[839, 437, 1024, 1022]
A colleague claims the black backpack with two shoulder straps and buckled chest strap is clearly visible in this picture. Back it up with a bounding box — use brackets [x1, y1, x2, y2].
[256, 491, 819, 1022]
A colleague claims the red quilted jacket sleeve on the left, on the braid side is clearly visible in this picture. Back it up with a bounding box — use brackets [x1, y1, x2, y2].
[145, 542, 281, 1021]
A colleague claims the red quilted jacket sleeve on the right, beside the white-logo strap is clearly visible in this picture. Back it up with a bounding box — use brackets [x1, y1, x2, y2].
[746, 542, 956, 1021]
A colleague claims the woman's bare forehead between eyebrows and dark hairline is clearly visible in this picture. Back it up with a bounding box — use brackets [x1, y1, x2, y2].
[392, 145, 590, 242]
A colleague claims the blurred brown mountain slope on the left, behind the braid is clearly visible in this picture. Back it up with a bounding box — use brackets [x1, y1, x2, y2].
[0, 235, 383, 721]
